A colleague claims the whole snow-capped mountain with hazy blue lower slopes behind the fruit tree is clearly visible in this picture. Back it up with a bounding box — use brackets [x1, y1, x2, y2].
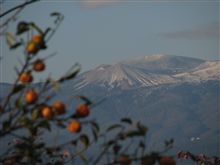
[0, 55, 220, 160]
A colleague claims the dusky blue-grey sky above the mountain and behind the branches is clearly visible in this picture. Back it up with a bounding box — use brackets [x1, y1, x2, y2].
[0, 0, 220, 82]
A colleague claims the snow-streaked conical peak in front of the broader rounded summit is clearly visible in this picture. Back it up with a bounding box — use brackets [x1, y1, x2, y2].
[75, 63, 175, 89]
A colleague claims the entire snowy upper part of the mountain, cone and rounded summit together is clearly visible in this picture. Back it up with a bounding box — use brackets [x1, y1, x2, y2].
[74, 55, 220, 89]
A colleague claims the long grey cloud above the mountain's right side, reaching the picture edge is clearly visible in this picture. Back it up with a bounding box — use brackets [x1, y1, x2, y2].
[160, 23, 220, 40]
